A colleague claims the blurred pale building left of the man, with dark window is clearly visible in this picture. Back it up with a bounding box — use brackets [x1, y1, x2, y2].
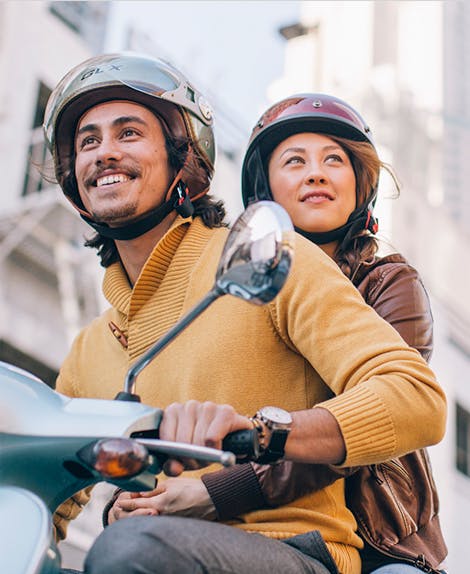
[0, 2, 107, 384]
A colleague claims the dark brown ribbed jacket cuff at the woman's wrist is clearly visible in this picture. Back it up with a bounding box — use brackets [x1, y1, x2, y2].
[201, 463, 266, 520]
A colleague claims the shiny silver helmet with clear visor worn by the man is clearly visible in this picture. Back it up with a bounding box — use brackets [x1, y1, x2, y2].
[43, 52, 215, 239]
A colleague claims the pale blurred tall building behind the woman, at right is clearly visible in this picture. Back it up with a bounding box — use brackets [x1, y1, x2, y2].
[269, 0, 470, 574]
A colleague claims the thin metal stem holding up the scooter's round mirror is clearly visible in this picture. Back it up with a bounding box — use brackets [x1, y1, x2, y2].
[124, 285, 224, 394]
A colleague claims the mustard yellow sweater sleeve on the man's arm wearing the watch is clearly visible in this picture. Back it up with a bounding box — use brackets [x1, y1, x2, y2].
[271, 237, 446, 466]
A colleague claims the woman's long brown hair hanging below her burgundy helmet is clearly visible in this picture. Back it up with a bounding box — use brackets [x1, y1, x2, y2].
[328, 135, 400, 280]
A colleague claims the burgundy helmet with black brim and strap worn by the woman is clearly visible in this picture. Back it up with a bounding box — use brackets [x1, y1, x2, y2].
[242, 94, 378, 244]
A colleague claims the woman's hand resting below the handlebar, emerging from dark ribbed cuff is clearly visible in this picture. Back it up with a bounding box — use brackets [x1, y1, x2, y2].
[108, 477, 216, 524]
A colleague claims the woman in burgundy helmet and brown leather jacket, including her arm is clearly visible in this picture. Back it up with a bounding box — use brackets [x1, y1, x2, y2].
[104, 94, 447, 574]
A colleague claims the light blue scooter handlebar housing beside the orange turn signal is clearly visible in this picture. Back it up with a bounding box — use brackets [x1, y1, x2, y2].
[0, 362, 162, 512]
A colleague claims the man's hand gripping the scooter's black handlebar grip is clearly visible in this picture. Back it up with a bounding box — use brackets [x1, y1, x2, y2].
[159, 401, 253, 476]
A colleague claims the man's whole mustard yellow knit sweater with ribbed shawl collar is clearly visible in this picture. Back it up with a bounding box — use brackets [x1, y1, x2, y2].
[57, 218, 445, 574]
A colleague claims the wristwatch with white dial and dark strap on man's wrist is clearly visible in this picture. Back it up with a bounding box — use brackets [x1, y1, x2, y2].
[251, 407, 292, 464]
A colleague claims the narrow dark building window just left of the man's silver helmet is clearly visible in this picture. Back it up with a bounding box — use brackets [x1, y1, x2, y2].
[23, 82, 52, 195]
